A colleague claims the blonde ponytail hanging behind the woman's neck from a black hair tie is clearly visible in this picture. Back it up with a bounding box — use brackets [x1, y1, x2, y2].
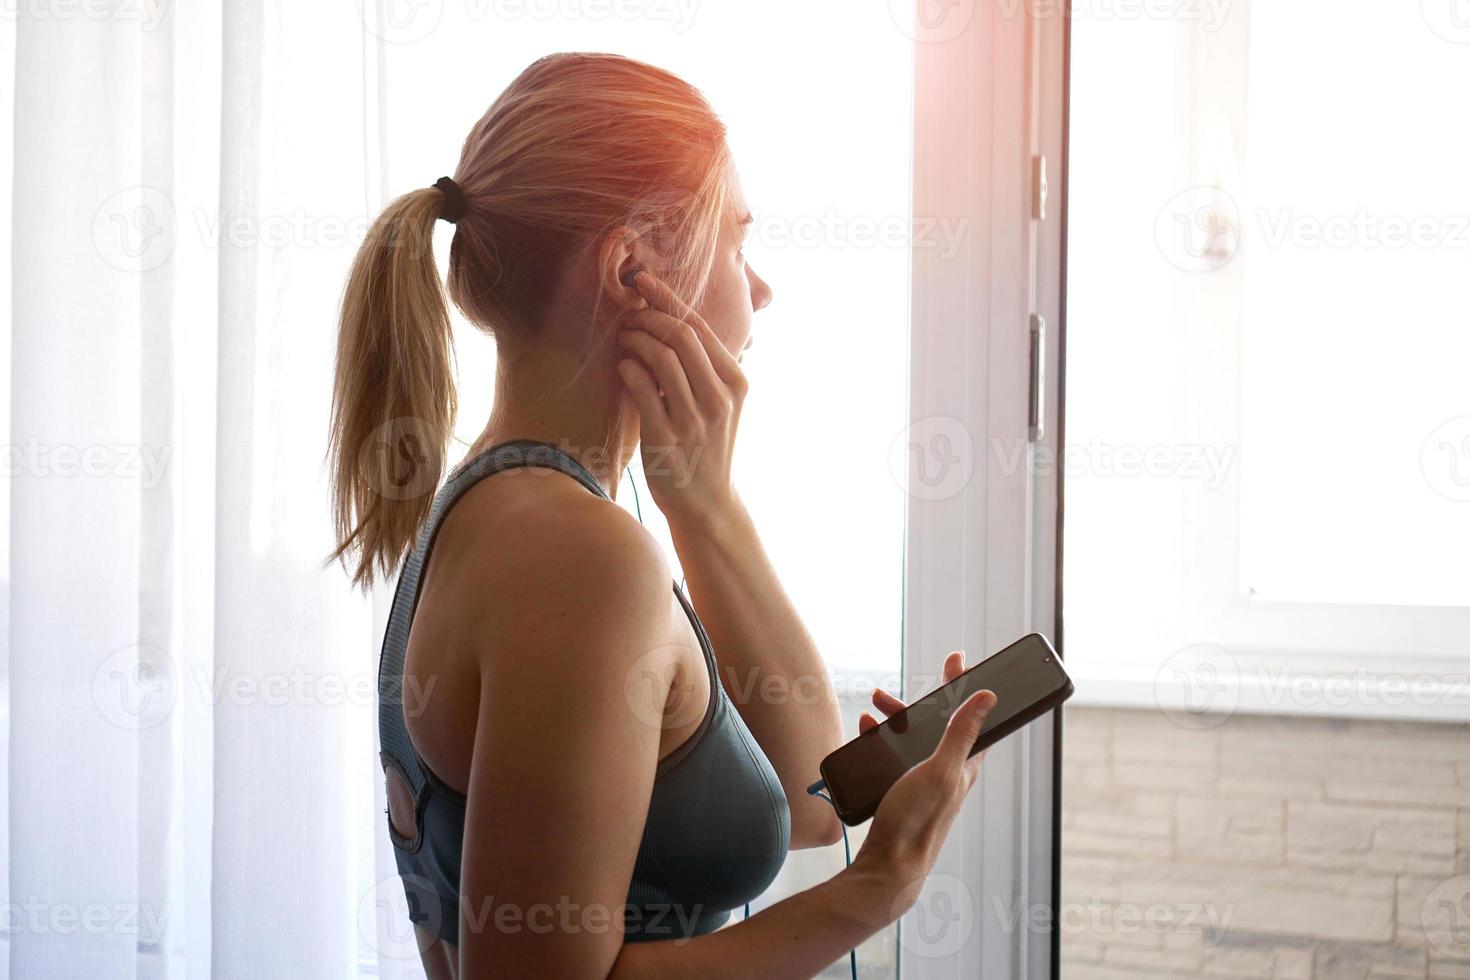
[329, 188, 457, 589]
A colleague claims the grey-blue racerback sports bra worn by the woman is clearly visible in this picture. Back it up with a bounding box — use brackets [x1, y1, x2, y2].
[378, 439, 791, 945]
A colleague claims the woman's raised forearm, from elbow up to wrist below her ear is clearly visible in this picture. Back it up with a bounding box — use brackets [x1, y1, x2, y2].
[670, 495, 842, 846]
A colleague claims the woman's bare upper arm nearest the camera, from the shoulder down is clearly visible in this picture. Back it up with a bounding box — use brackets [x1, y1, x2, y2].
[460, 514, 672, 979]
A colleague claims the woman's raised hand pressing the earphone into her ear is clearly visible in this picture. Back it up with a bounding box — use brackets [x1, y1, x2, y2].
[617, 270, 748, 526]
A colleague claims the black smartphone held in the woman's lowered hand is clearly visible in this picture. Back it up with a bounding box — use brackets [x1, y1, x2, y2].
[820, 633, 1072, 826]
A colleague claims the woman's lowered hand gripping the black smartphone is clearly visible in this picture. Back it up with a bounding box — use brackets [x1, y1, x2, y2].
[853, 691, 995, 918]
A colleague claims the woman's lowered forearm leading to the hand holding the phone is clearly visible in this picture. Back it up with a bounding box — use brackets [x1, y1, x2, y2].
[609, 865, 903, 980]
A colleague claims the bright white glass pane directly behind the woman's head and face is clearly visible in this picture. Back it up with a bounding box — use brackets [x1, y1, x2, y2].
[385, 11, 913, 977]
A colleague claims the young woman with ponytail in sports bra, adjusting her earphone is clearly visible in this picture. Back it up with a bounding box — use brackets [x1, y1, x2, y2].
[332, 54, 994, 979]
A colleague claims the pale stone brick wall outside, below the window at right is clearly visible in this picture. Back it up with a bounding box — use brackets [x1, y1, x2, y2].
[1060, 707, 1470, 980]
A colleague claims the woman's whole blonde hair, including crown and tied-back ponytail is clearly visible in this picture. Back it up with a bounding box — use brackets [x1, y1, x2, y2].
[328, 53, 729, 589]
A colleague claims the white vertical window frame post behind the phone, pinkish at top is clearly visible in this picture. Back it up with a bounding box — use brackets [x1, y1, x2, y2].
[900, 4, 1069, 980]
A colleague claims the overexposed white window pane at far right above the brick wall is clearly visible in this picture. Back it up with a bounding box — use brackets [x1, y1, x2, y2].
[1241, 0, 1470, 605]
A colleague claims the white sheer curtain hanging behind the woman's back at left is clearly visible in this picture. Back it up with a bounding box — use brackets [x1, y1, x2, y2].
[0, 0, 402, 979]
